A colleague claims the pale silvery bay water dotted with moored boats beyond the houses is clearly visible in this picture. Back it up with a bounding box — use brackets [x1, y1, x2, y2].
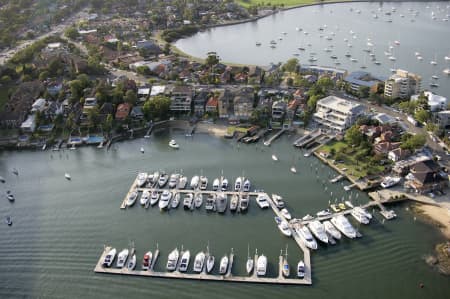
[176, 2, 450, 97]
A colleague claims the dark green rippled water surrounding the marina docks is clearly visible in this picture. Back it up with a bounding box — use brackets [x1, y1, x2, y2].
[0, 132, 450, 298]
